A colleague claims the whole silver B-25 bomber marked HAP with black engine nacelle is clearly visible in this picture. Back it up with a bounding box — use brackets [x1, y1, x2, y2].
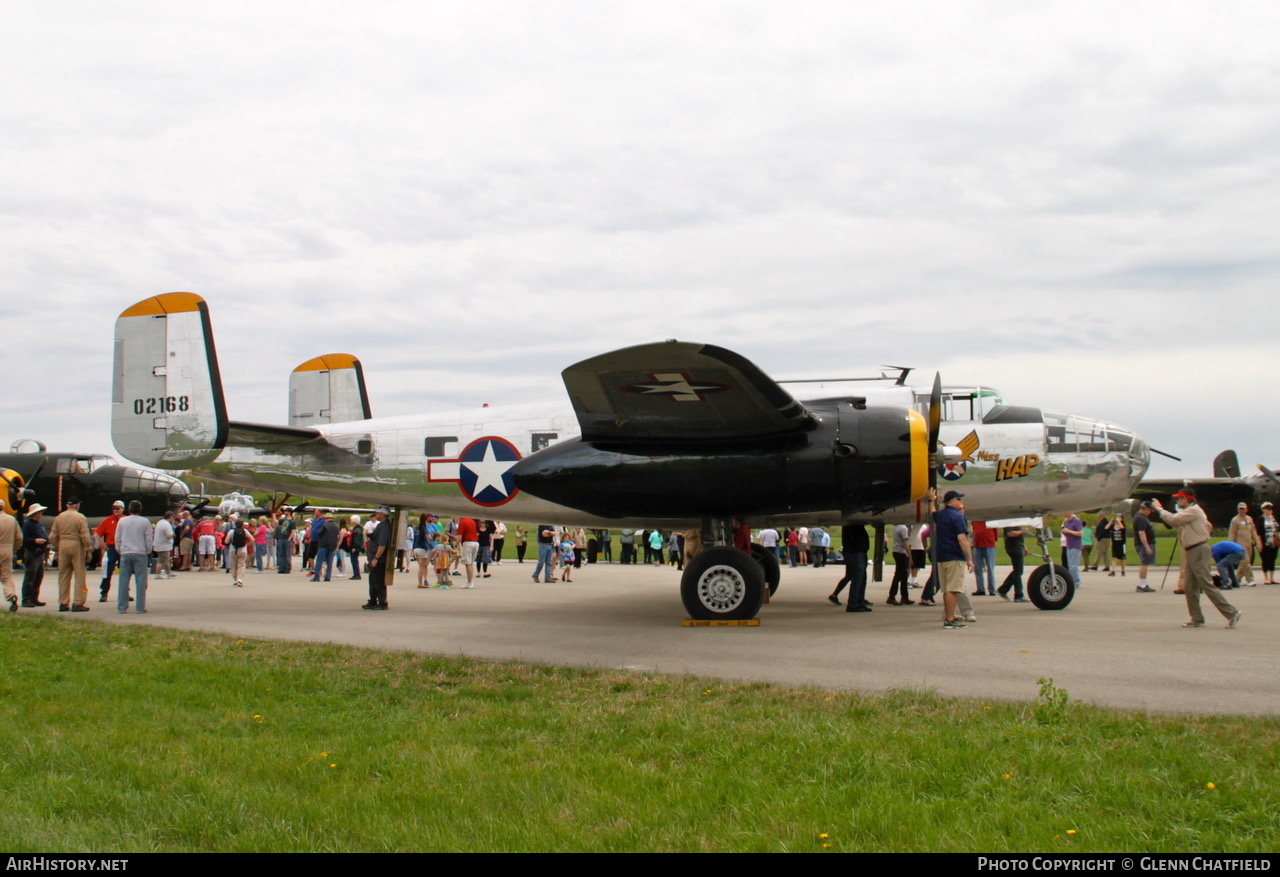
[111, 292, 1149, 620]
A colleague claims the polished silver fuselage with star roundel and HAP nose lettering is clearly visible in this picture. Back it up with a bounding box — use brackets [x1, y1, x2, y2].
[192, 385, 1148, 527]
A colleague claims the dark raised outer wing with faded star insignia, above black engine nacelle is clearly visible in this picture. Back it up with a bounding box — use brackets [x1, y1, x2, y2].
[561, 341, 813, 440]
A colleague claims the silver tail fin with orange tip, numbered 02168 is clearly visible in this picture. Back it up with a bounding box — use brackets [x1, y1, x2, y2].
[111, 292, 228, 469]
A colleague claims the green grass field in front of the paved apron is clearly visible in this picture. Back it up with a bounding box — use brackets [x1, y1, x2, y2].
[0, 615, 1280, 853]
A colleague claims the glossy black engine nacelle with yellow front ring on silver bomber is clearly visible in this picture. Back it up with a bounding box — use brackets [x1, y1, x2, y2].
[515, 399, 928, 519]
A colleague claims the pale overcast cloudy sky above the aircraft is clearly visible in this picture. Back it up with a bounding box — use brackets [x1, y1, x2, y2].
[0, 0, 1280, 475]
